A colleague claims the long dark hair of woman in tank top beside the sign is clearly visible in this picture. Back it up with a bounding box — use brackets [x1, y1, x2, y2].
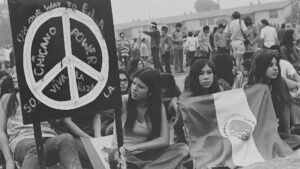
[124, 68, 162, 140]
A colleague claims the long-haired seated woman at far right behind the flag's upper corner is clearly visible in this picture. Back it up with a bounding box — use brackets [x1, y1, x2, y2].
[248, 50, 299, 148]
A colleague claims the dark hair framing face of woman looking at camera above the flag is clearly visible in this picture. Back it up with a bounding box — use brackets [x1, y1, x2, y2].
[188, 59, 220, 96]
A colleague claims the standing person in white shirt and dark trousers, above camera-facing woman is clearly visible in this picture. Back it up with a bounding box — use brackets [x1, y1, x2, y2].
[185, 31, 199, 66]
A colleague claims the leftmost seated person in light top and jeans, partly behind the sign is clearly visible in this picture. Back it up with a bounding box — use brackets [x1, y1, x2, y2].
[0, 77, 82, 169]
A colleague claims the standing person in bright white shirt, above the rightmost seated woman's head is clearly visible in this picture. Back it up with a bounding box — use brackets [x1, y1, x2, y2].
[260, 19, 278, 49]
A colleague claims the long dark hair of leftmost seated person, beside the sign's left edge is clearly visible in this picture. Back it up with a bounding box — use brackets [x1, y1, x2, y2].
[0, 76, 19, 117]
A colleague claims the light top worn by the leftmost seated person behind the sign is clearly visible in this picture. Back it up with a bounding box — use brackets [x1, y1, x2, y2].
[0, 94, 57, 153]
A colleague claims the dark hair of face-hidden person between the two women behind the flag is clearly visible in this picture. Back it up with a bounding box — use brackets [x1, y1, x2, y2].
[212, 54, 234, 86]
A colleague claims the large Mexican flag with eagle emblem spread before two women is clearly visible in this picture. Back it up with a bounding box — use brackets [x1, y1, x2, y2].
[179, 85, 292, 169]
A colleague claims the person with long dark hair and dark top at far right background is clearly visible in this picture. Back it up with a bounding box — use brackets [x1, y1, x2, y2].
[280, 29, 299, 64]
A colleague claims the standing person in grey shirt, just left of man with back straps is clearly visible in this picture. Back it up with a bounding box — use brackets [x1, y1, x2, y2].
[214, 24, 229, 53]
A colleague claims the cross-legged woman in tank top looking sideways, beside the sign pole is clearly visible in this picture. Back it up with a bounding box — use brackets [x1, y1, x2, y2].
[109, 68, 189, 169]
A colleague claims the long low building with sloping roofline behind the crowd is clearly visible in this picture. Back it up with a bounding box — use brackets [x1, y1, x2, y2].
[115, 0, 299, 38]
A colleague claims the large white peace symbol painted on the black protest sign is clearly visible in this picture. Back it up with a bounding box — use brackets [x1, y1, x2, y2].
[18, 2, 110, 110]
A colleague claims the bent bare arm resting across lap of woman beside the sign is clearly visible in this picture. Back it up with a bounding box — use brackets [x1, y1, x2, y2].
[126, 105, 170, 153]
